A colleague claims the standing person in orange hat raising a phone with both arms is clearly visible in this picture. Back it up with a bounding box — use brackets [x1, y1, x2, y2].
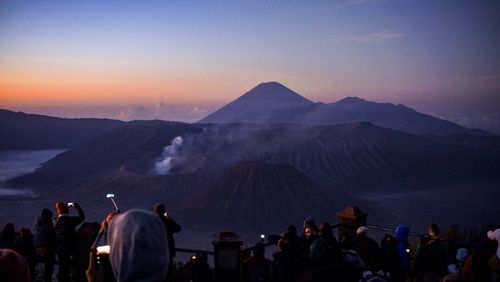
[54, 202, 85, 282]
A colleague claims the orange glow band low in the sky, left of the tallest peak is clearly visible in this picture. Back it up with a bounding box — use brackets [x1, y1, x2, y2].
[0, 64, 239, 105]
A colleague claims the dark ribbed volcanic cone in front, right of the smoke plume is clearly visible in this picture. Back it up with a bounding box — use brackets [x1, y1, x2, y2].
[177, 161, 345, 231]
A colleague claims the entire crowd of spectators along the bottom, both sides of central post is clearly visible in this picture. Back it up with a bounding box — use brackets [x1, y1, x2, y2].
[0, 205, 500, 282]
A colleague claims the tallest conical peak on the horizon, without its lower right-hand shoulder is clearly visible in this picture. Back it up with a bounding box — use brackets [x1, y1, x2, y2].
[198, 82, 312, 123]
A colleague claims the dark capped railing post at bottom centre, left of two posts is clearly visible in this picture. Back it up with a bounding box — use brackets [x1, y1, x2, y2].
[212, 232, 243, 282]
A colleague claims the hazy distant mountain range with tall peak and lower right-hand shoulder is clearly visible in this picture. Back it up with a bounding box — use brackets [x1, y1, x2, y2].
[197, 82, 495, 136]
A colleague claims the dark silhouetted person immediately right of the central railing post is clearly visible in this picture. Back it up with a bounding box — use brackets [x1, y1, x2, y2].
[241, 243, 271, 282]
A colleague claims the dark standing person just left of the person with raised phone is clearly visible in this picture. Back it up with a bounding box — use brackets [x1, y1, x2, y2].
[33, 209, 56, 282]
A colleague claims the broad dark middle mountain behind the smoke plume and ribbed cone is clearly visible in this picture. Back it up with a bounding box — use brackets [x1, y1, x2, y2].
[10, 122, 500, 194]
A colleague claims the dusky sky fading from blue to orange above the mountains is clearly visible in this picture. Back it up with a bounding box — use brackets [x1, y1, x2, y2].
[0, 0, 500, 132]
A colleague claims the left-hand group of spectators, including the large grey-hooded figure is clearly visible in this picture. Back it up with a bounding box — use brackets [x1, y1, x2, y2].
[0, 202, 181, 282]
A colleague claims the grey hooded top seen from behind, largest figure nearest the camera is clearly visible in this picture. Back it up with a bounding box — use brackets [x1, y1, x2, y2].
[108, 210, 169, 282]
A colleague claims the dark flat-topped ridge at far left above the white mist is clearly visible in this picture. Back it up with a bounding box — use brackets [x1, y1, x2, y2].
[0, 109, 125, 150]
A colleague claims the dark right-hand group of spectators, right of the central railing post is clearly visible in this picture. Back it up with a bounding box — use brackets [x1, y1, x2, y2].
[237, 218, 500, 282]
